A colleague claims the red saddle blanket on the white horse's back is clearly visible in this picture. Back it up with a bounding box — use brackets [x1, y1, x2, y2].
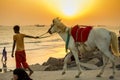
[71, 25, 92, 42]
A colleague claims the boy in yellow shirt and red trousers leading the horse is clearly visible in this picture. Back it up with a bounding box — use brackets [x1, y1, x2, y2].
[11, 25, 39, 76]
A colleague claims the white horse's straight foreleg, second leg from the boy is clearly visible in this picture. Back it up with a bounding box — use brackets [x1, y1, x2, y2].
[72, 50, 82, 78]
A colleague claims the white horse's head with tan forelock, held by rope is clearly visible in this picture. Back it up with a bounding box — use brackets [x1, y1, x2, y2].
[48, 18, 66, 34]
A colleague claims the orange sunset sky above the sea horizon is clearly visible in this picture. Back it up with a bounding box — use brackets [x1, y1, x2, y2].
[0, 0, 120, 26]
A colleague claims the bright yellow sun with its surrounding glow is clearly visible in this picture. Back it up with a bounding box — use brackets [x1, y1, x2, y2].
[42, 0, 96, 18]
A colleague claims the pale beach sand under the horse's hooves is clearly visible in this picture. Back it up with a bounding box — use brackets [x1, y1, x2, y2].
[0, 69, 120, 80]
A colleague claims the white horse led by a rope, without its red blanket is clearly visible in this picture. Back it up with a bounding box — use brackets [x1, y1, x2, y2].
[48, 18, 119, 79]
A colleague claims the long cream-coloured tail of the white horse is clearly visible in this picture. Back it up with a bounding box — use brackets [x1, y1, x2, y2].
[110, 32, 120, 56]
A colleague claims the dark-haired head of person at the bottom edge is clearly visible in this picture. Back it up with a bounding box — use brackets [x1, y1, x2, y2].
[13, 68, 32, 80]
